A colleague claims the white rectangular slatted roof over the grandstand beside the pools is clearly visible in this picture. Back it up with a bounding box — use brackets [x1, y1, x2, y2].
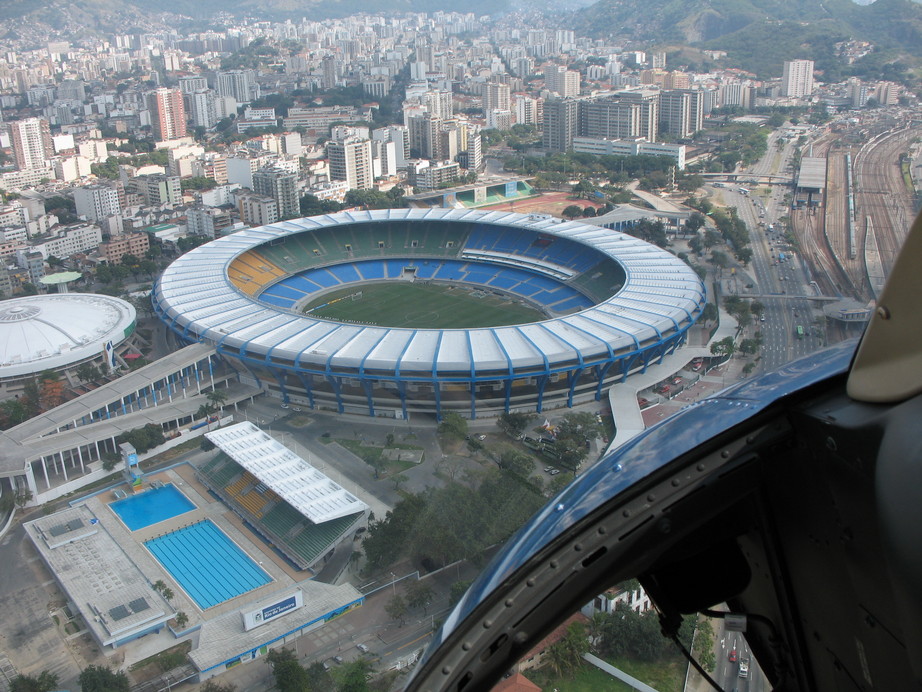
[205, 422, 368, 524]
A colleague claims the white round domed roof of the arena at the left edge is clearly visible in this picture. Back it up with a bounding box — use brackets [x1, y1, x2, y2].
[0, 293, 136, 378]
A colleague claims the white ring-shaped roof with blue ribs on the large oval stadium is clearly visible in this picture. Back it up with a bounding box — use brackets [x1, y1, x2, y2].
[156, 209, 705, 377]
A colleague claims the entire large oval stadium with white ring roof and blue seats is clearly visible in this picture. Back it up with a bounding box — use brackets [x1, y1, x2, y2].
[152, 209, 705, 419]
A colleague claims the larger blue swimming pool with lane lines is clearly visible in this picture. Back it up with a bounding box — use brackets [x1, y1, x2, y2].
[144, 519, 272, 610]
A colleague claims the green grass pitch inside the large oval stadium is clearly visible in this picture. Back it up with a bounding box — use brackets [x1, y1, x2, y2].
[304, 281, 547, 329]
